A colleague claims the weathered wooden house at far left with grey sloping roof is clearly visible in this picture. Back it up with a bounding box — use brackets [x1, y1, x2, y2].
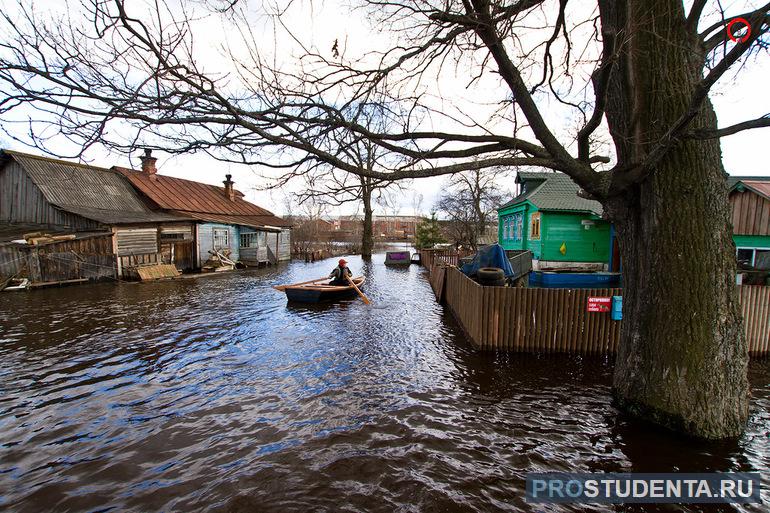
[0, 151, 193, 278]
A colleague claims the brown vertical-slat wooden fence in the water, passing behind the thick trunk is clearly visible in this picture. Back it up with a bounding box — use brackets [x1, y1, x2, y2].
[429, 264, 770, 356]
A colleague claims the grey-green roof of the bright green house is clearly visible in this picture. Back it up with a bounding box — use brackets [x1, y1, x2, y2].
[500, 172, 602, 216]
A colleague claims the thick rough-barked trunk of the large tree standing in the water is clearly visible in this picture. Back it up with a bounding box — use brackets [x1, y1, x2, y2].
[600, 0, 748, 439]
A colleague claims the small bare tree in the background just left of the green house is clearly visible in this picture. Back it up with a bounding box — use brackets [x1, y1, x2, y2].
[436, 168, 509, 250]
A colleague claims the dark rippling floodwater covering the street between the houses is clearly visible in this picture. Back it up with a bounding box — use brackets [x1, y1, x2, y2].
[0, 255, 770, 512]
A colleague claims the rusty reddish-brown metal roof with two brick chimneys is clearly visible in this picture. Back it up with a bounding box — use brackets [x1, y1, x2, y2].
[113, 167, 291, 226]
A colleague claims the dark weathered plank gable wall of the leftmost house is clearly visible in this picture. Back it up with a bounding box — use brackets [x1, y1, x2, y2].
[0, 161, 100, 230]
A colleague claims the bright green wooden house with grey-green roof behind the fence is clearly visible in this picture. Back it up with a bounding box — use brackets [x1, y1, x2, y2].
[497, 172, 613, 269]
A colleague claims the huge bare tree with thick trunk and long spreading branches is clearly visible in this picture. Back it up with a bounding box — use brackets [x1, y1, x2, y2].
[0, 0, 770, 438]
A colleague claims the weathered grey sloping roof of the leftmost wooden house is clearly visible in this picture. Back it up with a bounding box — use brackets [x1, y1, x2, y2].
[3, 150, 187, 224]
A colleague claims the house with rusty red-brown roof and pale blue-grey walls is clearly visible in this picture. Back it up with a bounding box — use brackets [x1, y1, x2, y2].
[113, 152, 291, 266]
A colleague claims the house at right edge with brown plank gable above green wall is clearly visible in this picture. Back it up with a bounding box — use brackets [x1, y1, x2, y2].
[728, 176, 770, 270]
